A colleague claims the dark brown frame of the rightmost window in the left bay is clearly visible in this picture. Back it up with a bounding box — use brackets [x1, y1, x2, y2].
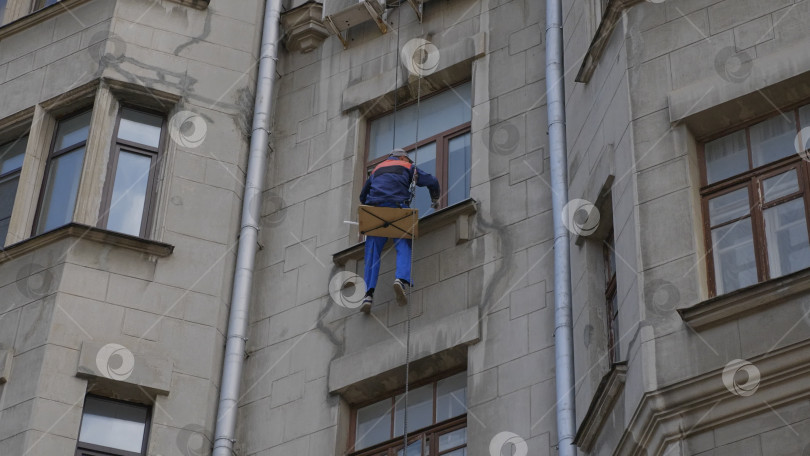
[98, 104, 168, 238]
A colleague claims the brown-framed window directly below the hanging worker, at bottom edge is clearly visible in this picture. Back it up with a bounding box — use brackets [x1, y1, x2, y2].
[352, 372, 467, 456]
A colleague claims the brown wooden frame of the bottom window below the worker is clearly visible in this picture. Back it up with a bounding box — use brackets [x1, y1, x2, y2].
[347, 369, 469, 456]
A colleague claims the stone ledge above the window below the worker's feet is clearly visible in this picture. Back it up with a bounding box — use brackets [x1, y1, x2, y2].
[329, 307, 481, 404]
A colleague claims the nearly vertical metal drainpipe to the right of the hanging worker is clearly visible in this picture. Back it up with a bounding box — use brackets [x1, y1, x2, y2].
[546, 0, 577, 456]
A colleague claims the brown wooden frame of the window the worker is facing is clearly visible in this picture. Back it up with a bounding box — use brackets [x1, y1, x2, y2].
[364, 80, 472, 210]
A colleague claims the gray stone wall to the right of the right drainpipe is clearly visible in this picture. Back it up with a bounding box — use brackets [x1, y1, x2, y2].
[565, 0, 810, 454]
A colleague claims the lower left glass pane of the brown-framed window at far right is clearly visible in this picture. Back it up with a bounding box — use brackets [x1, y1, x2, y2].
[712, 218, 757, 295]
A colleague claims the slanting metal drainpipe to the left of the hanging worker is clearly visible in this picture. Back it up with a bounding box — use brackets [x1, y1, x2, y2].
[213, 0, 281, 456]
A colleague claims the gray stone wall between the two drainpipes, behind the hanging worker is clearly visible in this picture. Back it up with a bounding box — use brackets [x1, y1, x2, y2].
[240, 0, 556, 455]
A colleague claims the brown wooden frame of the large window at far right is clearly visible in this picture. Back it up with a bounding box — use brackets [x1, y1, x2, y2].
[698, 101, 810, 297]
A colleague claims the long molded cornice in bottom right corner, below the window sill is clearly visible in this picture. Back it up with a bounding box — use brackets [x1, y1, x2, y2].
[612, 340, 810, 456]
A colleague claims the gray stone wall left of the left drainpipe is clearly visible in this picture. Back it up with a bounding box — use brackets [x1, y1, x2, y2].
[0, 0, 264, 456]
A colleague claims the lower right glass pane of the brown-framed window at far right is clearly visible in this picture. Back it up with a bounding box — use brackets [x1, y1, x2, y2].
[762, 198, 810, 277]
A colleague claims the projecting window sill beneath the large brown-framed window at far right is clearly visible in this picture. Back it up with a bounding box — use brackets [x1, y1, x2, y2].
[678, 268, 810, 329]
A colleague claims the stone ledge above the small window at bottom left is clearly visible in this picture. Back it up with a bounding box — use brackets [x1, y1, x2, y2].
[76, 341, 173, 397]
